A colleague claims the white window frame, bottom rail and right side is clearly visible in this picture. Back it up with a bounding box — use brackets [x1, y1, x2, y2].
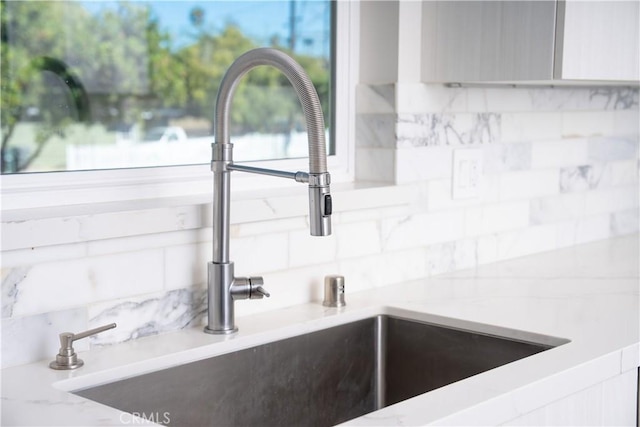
[0, 0, 359, 217]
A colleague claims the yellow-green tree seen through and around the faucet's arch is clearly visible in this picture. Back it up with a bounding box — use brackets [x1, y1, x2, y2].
[170, 24, 330, 134]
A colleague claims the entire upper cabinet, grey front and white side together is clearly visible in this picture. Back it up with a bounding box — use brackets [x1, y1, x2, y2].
[421, 0, 640, 84]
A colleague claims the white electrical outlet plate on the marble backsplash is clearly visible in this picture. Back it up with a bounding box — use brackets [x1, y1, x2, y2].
[451, 148, 482, 199]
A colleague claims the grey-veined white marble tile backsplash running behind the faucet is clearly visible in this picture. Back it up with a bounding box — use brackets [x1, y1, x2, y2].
[2, 84, 639, 366]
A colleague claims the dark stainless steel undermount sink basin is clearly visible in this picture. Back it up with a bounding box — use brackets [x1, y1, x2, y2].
[74, 315, 564, 426]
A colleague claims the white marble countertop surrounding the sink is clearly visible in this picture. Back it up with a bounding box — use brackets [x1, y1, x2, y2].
[0, 235, 640, 426]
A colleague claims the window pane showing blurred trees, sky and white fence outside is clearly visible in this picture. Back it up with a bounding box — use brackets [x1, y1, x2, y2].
[1, 0, 336, 174]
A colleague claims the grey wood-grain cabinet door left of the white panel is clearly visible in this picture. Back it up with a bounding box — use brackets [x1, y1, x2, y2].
[422, 0, 556, 82]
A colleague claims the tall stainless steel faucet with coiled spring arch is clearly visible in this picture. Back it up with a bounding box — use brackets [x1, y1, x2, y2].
[205, 48, 332, 334]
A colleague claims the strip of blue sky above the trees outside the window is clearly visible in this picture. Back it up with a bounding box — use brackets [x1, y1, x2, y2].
[82, 0, 330, 56]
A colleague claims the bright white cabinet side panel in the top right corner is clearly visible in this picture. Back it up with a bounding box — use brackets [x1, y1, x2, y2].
[554, 0, 640, 80]
